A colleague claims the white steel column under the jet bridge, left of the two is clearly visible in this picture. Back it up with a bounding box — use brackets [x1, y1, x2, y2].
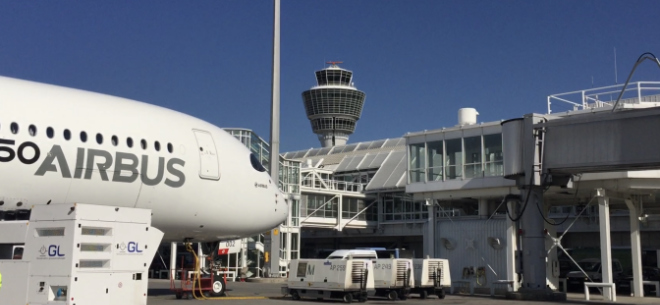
[596, 188, 613, 301]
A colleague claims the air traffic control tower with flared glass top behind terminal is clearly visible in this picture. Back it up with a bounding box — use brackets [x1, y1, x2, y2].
[302, 62, 366, 147]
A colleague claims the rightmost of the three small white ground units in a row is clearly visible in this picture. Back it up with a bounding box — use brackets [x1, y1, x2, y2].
[411, 258, 451, 299]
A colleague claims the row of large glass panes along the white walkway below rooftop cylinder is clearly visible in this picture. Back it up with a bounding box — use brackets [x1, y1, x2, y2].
[408, 133, 504, 183]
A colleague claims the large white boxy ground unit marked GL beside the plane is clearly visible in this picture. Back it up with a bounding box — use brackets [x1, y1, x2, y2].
[0, 204, 163, 305]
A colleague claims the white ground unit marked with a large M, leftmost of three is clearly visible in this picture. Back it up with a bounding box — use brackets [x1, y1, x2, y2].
[282, 258, 374, 303]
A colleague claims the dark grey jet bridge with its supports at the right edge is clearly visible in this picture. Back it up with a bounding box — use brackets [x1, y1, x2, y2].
[502, 107, 660, 298]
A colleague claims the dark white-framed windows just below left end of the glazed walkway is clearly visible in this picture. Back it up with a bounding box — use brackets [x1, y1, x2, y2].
[383, 193, 428, 221]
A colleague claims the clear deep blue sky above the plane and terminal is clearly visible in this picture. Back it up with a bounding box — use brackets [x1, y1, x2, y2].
[0, 0, 660, 151]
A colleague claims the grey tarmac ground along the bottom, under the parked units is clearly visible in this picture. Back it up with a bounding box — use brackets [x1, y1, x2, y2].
[148, 279, 660, 305]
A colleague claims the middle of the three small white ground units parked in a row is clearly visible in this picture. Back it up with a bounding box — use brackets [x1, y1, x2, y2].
[373, 258, 414, 300]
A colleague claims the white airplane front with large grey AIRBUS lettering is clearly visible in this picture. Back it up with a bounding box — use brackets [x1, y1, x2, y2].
[0, 76, 289, 242]
